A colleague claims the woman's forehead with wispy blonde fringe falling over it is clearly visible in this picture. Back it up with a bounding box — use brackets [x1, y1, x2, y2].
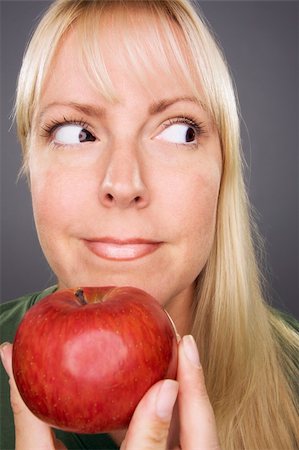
[42, 4, 202, 108]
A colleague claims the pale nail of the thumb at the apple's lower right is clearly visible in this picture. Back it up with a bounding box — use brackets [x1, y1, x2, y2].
[156, 380, 179, 421]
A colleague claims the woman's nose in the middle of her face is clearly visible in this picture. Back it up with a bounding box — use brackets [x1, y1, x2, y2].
[100, 142, 149, 209]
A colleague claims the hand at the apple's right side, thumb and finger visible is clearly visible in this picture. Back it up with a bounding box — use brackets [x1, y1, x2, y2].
[121, 336, 220, 450]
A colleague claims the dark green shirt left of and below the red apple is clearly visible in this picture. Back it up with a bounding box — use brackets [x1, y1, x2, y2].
[0, 286, 119, 450]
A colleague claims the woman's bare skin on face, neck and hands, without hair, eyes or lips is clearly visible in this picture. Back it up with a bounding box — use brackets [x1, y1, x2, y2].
[1, 12, 222, 450]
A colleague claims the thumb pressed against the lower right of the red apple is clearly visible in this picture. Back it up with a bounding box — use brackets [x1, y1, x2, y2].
[121, 380, 178, 450]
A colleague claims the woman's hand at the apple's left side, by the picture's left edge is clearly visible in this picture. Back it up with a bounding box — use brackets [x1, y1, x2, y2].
[1, 343, 65, 450]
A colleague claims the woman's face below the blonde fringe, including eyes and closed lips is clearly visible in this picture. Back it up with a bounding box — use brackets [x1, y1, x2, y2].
[29, 18, 222, 316]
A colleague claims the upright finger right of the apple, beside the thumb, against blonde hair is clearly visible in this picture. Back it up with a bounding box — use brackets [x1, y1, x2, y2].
[178, 336, 220, 450]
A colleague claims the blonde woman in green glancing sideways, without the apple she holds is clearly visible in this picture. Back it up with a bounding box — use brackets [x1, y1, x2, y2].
[1, 0, 299, 450]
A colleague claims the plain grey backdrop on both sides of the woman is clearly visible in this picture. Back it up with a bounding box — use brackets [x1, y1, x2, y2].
[1, 0, 299, 317]
